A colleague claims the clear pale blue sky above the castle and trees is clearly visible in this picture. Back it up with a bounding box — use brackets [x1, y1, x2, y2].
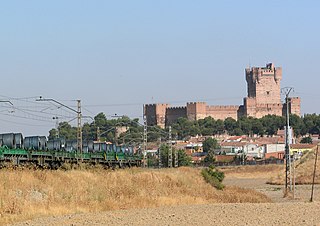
[0, 0, 320, 135]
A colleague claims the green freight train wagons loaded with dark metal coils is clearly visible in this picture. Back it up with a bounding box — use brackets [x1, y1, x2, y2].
[0, 133, 142, 169]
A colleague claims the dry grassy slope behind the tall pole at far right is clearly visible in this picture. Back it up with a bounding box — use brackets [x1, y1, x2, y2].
[268, 151, 320, 185]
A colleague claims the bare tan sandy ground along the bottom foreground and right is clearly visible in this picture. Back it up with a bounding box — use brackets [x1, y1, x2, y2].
[9, 177, 320, 226]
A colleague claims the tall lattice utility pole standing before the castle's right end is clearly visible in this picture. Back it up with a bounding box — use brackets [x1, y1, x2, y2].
[284, 87, 293, 196]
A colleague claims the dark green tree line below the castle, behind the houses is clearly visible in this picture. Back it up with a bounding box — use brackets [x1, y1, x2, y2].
[48, 113, 320, 145]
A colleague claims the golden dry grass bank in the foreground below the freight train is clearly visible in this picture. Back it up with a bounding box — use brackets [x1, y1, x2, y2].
[0, 168, 270, 225]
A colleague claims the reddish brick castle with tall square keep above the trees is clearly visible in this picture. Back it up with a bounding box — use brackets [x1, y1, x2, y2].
[144, 63, 300, 128]
